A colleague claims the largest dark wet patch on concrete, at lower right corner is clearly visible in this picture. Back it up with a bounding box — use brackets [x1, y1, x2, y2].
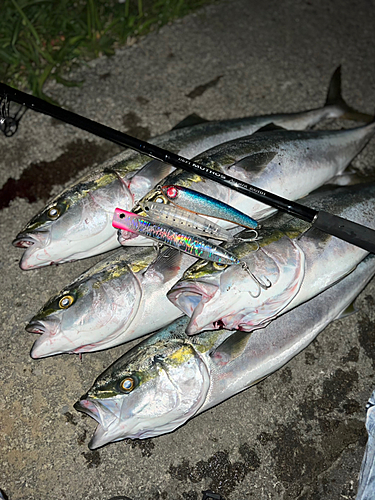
[258, 368, 366, 500]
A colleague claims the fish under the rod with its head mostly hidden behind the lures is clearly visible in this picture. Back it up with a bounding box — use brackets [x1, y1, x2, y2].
[136, 120, 375, 245]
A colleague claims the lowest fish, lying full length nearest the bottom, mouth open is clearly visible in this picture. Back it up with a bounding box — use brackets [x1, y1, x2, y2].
[74, 255, 375, 450]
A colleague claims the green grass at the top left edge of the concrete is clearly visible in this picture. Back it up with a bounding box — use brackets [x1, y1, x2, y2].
[0, 0, 215, 100]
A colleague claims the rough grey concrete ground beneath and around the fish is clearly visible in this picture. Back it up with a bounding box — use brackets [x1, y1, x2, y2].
[0, 0, 375, 500]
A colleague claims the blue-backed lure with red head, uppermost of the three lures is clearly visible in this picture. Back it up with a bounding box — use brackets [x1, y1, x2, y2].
[161, 185, 258, 229]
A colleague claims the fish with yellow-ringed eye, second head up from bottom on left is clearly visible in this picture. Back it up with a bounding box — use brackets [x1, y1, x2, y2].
[26, 247, 196, 359]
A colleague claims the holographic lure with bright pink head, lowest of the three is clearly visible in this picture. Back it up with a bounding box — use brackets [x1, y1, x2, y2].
[112, 208, 240, 265]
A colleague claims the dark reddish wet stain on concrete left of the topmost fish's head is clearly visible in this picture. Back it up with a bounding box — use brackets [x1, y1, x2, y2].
[0, 139, 115, 209]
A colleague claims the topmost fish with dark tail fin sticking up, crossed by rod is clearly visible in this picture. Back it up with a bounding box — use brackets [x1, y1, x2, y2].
[13, 68, 367, 270]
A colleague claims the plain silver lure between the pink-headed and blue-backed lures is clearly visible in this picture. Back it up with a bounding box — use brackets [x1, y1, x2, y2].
[141, 201, 233, 241]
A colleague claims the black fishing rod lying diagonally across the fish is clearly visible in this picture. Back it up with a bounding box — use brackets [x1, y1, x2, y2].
[0, 83, 375, 253]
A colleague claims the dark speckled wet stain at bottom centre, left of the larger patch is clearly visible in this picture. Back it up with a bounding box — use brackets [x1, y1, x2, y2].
[168, 443, 260, 496]
